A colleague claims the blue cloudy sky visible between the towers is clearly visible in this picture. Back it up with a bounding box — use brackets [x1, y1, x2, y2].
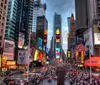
[42, 0, 75, 50]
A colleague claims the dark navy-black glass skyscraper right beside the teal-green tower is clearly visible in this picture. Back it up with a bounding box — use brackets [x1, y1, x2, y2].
[15, 0, 33, 46]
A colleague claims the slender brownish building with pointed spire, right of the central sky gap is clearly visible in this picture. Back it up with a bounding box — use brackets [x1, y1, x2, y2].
[67, 14, 76, 59]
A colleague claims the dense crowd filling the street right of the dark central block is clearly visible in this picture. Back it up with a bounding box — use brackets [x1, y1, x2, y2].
[66, 65, 100, 85]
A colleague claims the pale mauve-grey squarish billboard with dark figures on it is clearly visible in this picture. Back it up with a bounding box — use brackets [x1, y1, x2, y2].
[17, 50, 29, 65]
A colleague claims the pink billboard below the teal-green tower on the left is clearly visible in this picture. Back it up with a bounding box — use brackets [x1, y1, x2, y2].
[3, 40, 15, 60]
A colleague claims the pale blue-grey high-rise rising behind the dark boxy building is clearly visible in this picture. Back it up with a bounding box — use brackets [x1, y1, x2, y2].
[32, 0, 46, 32]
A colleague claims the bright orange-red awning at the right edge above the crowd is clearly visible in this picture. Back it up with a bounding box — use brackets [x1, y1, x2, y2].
[84, 57, 100, 66]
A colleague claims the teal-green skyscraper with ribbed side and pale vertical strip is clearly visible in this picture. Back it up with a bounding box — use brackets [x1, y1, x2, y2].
[5, 0, 18, 41]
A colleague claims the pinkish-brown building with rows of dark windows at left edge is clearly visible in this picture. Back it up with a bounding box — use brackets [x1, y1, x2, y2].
[0, 0, 8, 54]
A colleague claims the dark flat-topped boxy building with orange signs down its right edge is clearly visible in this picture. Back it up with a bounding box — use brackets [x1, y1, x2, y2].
[36, 16, 48, 50]
